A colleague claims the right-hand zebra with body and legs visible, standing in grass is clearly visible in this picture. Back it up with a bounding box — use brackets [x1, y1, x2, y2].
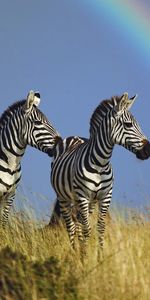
[51, 93, 150, 246]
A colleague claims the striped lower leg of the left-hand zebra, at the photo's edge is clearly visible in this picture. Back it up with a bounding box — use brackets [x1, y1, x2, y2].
[1, 191, 15, 228]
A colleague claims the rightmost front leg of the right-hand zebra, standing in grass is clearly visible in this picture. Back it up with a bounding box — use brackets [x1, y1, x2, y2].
[97, 188, 112, 247]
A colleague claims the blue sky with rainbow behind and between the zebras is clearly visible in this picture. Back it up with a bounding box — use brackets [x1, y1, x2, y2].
[0, 0, 150, 217]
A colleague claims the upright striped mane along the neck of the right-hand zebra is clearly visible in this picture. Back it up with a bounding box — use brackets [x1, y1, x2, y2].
[90, 96, 121, 134]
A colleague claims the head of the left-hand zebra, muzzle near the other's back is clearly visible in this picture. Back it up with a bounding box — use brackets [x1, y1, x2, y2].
[23, 91, 59, 156]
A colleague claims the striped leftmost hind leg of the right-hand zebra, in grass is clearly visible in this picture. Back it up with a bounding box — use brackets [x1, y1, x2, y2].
[59, 200, 76, 246]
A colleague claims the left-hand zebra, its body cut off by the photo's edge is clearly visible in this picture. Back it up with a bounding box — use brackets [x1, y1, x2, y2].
[0, 91, 60, 226]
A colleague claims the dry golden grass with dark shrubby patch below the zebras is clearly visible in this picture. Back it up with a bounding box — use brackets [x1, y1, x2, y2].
[0, 209, 150, 300]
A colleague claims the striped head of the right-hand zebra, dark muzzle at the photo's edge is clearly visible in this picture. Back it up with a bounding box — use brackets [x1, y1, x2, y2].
[111, 93, 150, 160]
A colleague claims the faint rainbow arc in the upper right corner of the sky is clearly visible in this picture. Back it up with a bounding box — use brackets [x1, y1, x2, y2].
[85, 0, 150, 64]
